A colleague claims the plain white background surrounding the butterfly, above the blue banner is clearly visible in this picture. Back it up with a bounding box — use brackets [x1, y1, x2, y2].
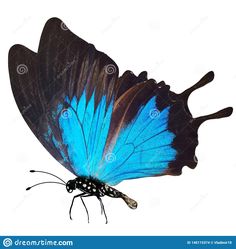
[0, 0, 236, 235]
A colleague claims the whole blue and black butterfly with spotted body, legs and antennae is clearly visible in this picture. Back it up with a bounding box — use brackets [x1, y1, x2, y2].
[9, 18, 232, 222]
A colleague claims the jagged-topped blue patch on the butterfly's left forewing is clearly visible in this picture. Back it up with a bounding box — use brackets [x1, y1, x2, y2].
[44, 91, 113, 177]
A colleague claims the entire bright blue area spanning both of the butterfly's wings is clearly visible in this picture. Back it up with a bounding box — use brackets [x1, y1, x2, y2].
[43, 91, 176, 185]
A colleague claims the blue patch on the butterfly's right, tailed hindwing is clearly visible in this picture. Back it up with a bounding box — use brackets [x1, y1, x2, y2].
[98, 97, 177, 185]
